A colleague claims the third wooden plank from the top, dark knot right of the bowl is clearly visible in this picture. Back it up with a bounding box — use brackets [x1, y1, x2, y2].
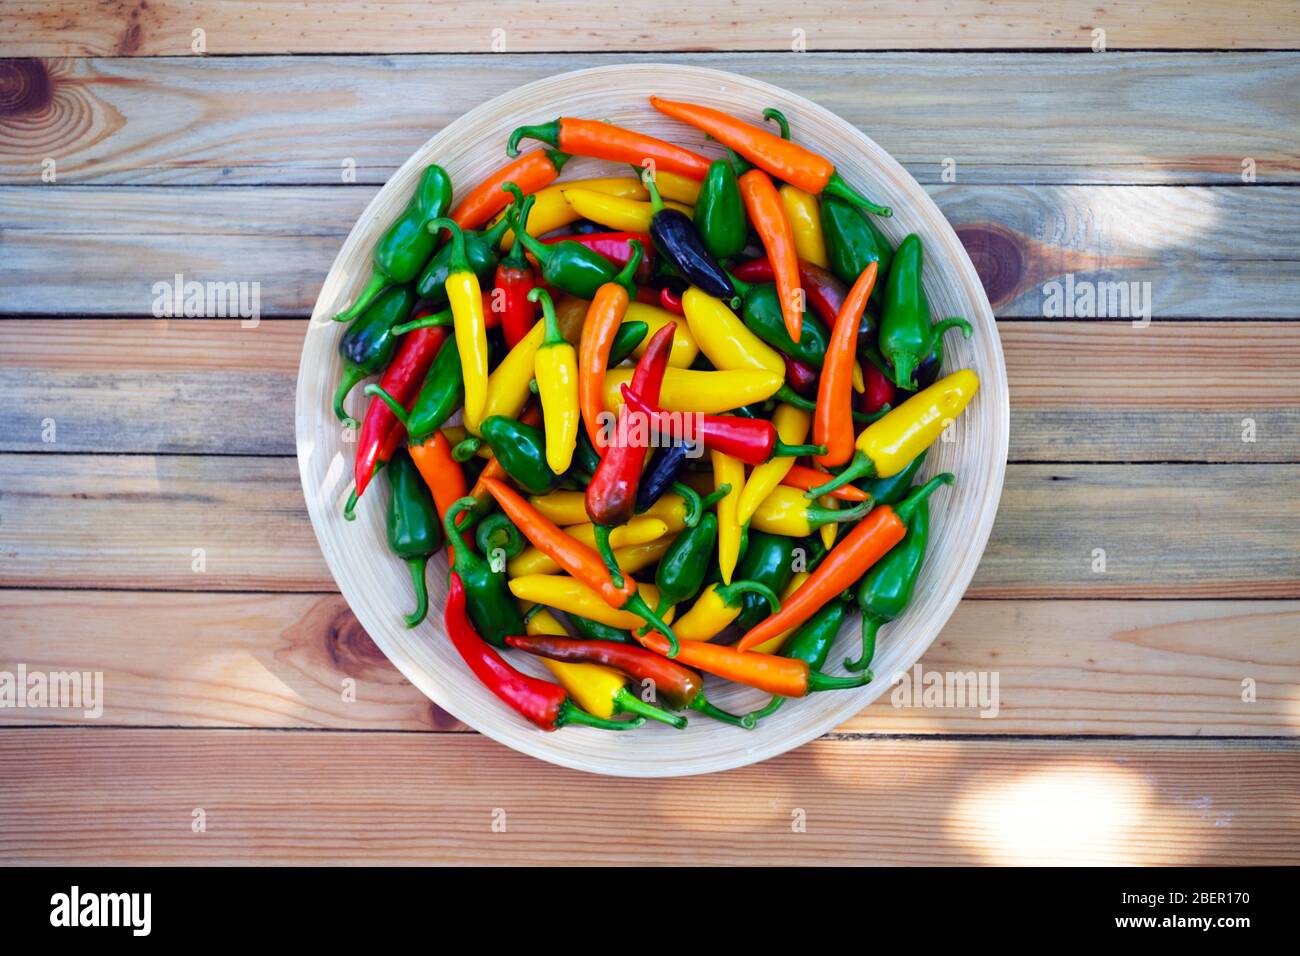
[0, 185, 1300, 324]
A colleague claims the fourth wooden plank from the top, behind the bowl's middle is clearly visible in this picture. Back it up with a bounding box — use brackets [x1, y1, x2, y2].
[0, 319, 1300, 462]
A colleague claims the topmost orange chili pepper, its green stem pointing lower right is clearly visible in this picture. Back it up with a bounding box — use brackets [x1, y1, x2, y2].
[650, 96, 893, 218]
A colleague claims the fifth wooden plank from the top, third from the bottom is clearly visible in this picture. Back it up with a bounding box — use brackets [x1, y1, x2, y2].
[0, 454, 1300, 600]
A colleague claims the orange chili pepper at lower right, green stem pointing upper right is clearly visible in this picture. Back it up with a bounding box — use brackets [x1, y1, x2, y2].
[738, 472, 953, 655]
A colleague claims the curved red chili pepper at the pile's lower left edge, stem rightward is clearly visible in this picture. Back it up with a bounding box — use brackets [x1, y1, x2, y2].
[443, 571, 645, 730]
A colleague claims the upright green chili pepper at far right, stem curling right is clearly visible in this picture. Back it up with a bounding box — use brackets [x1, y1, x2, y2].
[878, 233, 971, 389]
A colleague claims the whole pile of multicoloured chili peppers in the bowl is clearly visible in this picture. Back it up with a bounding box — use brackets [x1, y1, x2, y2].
[334, 96, 979, 730]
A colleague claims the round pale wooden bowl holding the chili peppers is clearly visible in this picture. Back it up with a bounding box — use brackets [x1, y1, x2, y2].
[296, 65, 1009, 777]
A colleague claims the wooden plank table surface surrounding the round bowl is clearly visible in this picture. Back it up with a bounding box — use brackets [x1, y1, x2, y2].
[0, 0, 1300, 864]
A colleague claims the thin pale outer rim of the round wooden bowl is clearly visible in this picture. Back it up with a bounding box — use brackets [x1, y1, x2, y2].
[294, 62, 1010, 778]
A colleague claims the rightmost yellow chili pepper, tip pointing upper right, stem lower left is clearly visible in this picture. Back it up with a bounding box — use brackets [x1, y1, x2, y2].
[803, 368, 979, 498]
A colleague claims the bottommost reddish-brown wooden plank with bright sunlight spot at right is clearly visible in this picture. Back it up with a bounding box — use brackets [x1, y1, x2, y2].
[0, 728, 1300, 866]
